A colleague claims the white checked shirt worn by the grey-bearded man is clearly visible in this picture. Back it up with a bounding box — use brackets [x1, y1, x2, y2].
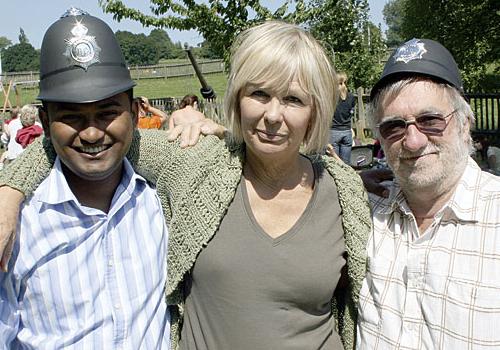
[357, 158, 500, 350]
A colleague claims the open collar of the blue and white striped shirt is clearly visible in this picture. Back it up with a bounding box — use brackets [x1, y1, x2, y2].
[35, 157, 146, 205]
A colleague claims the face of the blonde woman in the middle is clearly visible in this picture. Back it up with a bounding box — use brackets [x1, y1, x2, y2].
[240, 81, 313, 157]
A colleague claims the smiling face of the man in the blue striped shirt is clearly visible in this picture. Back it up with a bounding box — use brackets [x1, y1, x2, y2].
[43, 93, 136, 181]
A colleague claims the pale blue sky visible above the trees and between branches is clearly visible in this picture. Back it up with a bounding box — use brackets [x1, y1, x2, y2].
[0, 0, 387, 48]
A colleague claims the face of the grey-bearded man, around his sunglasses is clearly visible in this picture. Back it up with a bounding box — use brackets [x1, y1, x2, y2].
[378, 81, 469, 190]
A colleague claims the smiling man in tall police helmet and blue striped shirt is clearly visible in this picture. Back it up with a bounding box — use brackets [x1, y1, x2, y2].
[0, 9, 170, 349]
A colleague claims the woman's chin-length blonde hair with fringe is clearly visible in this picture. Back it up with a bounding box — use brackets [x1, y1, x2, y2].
[224, 21, 338, 153]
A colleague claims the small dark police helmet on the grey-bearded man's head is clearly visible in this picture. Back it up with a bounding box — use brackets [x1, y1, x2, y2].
[370, 39, 464, 100]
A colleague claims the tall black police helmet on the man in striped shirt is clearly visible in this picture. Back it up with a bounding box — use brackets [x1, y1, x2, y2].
[38, 8, 135, 103]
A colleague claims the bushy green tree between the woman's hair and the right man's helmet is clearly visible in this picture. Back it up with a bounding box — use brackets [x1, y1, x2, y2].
[306, 0, 384, 88]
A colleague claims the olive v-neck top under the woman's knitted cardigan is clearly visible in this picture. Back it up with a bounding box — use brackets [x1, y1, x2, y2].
[180, 163, 345, 350]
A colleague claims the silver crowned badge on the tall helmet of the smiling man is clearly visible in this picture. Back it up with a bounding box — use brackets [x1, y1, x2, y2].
[64, 21, 101, 70]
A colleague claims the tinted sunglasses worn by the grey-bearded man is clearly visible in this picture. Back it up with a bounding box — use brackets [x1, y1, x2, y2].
[377, 110, 457, 141]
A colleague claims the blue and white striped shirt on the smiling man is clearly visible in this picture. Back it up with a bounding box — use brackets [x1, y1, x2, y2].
[0, 159, 170, 350]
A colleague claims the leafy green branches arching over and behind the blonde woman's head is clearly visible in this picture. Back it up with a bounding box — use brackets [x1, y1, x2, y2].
[99, 0, 384, 87]
